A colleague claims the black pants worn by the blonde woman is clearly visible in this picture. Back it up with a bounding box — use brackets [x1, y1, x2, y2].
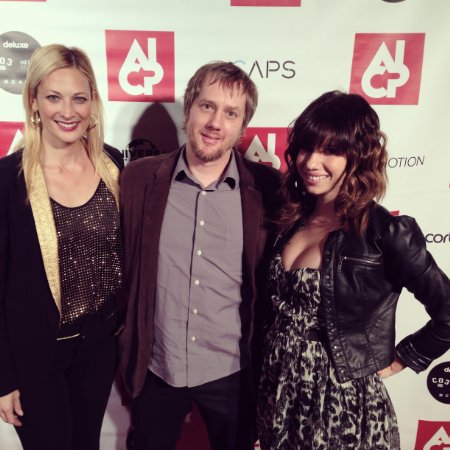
[16, 326, 117, 450]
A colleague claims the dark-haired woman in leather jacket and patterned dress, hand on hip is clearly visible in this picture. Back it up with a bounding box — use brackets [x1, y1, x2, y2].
[258, 91, 450, 450]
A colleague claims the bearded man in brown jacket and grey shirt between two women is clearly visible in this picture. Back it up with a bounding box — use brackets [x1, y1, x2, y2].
[121, 62, 279, 450]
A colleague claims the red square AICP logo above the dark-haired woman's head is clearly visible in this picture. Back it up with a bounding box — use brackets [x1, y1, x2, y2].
[350, 33, 425, 105]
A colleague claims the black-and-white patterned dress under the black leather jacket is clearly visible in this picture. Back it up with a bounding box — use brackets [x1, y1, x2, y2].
[258, 255, 400, 450]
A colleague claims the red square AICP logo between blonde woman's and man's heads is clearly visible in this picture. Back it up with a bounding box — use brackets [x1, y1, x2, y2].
[106, 30, 175, 102]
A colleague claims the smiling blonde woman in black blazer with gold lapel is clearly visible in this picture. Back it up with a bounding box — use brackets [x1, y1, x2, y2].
[0, 45, 123, 450]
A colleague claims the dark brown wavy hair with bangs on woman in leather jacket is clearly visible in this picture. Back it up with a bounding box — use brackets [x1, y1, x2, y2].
[277, 91, 387, 234]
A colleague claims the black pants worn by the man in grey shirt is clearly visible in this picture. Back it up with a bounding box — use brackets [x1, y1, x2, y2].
[129, 371, 255, 450]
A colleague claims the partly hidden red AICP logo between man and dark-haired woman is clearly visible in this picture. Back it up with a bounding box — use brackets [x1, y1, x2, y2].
[238, 128, 288, 171]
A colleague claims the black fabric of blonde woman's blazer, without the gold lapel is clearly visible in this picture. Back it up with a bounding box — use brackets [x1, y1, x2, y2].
[0, 146, 123, 396]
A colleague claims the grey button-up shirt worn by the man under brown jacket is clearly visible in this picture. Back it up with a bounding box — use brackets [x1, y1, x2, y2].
[150, 151, 244, 387]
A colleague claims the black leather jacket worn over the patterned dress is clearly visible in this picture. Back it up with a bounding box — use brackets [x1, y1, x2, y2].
[275, 204, 450, 382]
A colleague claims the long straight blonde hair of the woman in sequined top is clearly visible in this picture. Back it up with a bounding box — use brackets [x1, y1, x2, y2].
[16, 44, 119, 202]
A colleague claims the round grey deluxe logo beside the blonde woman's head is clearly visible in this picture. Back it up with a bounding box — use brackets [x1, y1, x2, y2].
[0, 31, 40, 94]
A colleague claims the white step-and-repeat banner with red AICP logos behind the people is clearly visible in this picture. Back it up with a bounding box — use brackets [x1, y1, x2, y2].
[0, 0, 450, 450]
